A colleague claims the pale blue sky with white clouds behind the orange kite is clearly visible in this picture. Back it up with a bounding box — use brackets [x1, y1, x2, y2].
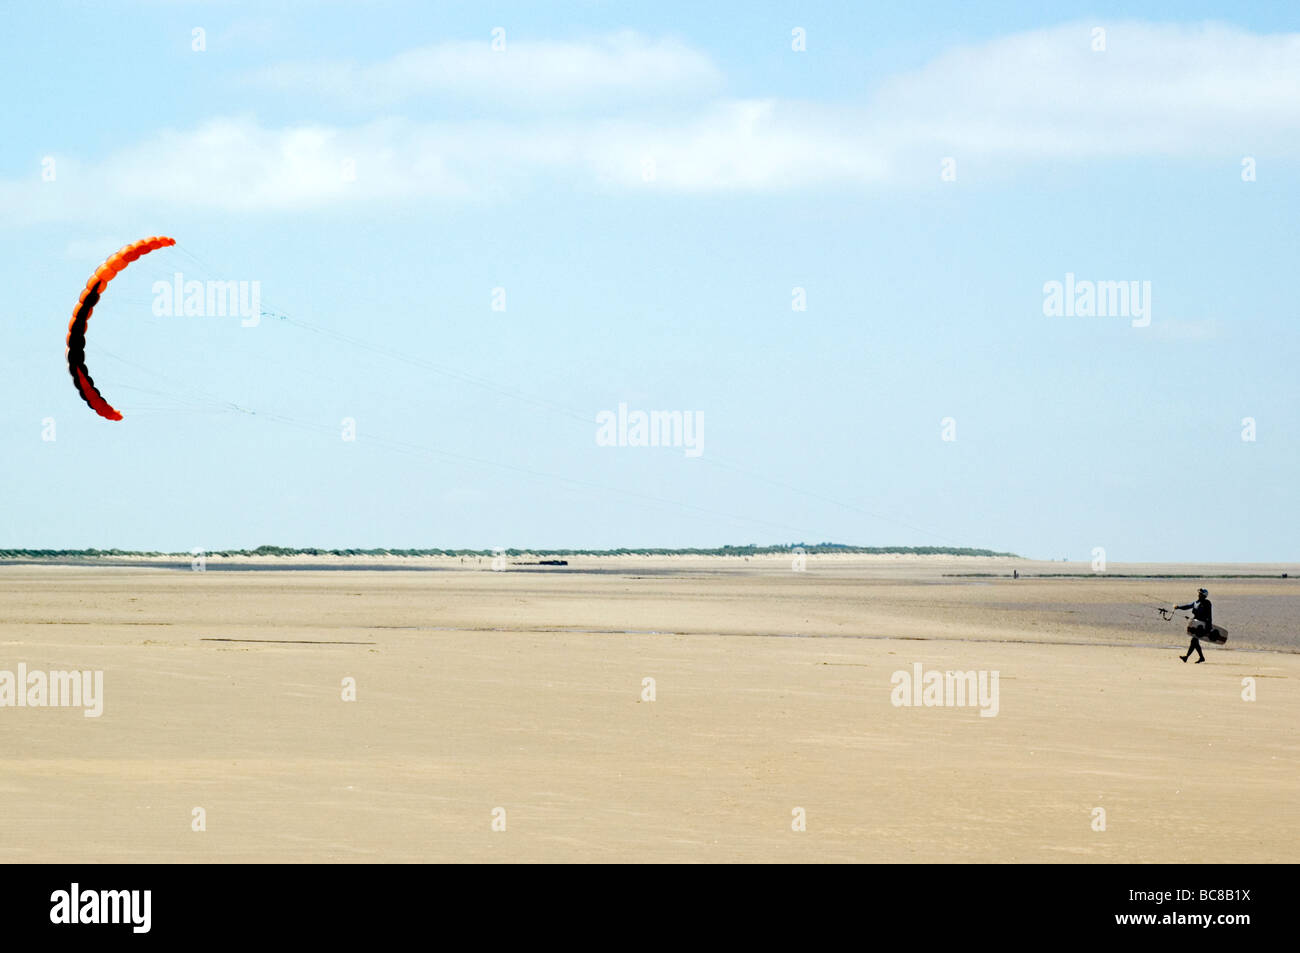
[0, 0, 1300, 563]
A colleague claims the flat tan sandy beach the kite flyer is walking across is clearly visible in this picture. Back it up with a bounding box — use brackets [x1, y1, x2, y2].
[0, 556, 1300, 863]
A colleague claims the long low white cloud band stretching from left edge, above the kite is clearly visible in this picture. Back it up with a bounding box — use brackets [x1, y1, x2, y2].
[0, 101, 884, 224]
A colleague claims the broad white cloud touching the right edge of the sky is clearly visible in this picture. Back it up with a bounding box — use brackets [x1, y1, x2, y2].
[871, 22, 1300, 159]
